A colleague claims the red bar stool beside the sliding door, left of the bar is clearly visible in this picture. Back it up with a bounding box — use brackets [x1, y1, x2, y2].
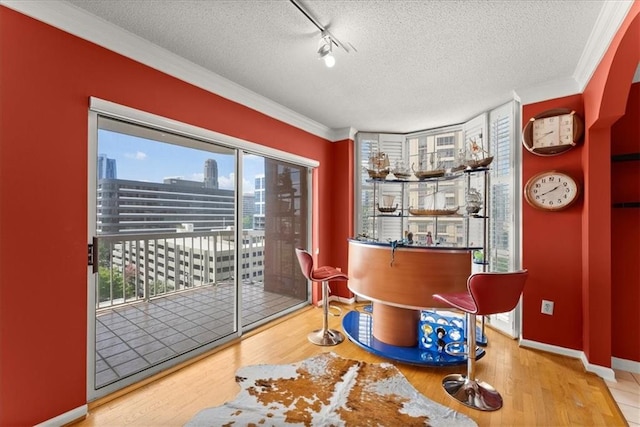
[296, 248, 349, 345]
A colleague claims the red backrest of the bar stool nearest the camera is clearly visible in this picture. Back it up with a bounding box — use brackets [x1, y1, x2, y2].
[467, 270, 529, 316]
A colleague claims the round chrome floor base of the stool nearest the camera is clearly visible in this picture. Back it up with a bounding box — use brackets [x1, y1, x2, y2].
[442, 374, 502, 411]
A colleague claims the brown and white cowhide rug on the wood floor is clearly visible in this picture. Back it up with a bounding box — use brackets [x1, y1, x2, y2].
[187, 353, 476, 427]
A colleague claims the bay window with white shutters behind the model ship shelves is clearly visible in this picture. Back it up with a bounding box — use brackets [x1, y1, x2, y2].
[355, 102, 519, 271]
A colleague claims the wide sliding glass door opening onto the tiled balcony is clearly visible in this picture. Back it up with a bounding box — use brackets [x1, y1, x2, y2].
[87, 107, 310, 400]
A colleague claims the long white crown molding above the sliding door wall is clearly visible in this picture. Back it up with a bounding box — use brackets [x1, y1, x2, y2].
[0, 0, 341, 141]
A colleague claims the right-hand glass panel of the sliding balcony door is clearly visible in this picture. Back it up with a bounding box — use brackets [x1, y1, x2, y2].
[241, 155, 310, 330]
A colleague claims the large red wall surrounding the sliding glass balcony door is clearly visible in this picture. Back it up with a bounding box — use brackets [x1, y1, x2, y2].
[0, 6, 353, 426]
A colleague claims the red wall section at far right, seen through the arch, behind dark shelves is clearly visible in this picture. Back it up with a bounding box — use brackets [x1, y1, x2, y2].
[611, 83, 640, 361]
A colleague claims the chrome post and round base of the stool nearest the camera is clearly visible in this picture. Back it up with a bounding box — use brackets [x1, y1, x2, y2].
[442, 313, 502, 411]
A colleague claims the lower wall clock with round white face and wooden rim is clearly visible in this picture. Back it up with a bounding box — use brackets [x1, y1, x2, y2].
[524, 171, 580, 211]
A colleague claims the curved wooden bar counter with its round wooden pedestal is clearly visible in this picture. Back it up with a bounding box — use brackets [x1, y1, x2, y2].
[348, 240, 478, 347]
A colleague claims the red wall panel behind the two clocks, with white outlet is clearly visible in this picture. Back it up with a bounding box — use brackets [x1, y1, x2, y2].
[522, 95, 584, 350]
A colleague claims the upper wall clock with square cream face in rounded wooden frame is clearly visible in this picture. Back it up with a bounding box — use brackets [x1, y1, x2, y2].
[522, 108, 584, 156]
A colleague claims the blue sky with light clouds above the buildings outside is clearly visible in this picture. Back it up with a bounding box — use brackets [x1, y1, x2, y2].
[98, 129, 264, 193]
